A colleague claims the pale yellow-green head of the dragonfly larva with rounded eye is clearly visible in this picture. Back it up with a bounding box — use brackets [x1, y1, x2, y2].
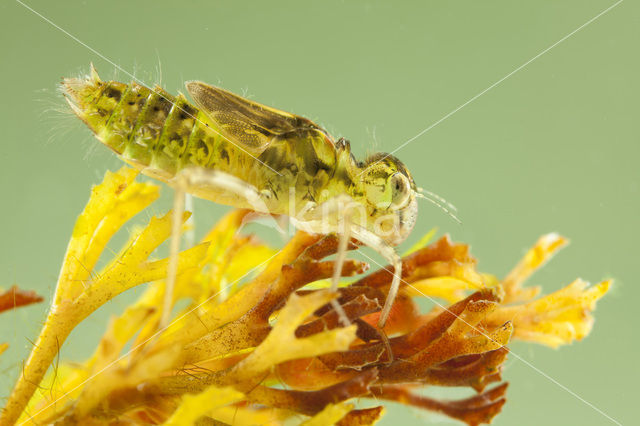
[360, 153, 418, 245]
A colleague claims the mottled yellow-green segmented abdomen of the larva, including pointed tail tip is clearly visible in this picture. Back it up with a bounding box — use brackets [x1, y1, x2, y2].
[63, 74, 254, 181]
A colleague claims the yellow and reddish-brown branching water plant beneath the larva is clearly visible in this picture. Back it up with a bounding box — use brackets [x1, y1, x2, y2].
[0, 168, 610, 425]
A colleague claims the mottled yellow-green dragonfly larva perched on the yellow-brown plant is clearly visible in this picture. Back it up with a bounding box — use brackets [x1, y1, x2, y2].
[62, 66, 456, 326]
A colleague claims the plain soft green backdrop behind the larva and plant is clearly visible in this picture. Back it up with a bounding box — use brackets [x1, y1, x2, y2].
[0, 0, 640, 425]
